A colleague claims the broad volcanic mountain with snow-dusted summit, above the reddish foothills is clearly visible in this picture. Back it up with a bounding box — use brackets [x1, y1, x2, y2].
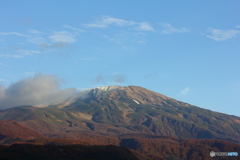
[0, 86, 240, 143]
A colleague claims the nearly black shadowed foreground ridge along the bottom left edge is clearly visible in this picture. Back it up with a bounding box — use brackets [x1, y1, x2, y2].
[0, 144, 151, 160]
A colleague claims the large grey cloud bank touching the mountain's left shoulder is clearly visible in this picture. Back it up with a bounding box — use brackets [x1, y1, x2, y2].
[0, 74, 76, 109]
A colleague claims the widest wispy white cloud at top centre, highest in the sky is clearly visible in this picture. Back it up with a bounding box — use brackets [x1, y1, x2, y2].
[84, 16, 136, 28]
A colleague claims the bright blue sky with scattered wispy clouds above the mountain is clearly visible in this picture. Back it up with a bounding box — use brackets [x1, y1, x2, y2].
[0, 0, 240, 116]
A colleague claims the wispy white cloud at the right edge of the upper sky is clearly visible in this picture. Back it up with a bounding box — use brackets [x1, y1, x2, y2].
[206, 29, 240, 41]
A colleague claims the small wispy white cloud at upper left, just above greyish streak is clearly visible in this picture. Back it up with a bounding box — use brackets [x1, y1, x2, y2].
[49, 31, 76, 43]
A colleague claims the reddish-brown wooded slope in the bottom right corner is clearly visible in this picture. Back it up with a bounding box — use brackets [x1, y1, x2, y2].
[119, 134, 240, 160]
